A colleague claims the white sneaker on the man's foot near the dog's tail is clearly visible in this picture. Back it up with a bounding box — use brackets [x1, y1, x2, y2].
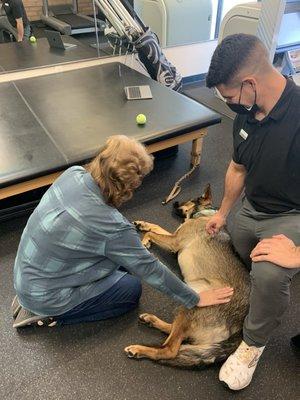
[219, 341, 265, 390]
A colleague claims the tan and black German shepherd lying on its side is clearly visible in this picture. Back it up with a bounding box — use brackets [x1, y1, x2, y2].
[125, 185, 250, 368]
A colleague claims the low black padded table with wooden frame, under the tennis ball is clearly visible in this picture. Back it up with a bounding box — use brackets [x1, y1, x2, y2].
[0, 62, 220, 211]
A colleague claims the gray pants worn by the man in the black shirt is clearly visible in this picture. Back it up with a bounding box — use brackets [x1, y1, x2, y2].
[230, 198, 300, 347]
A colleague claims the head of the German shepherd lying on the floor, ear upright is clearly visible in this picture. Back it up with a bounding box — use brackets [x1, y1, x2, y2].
[173, 184, 216, 220]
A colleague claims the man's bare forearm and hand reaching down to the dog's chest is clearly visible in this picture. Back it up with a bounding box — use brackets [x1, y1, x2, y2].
[206, 160, 246, 235]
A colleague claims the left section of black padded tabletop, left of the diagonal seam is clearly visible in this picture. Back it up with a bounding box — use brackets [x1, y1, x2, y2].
[0, 83, 67, 183]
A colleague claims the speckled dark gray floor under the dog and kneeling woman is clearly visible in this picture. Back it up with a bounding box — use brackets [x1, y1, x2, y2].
[0, 114, 300, 400]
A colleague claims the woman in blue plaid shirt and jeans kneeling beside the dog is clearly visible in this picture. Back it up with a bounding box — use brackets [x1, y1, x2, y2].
[12, 136, 232, 328]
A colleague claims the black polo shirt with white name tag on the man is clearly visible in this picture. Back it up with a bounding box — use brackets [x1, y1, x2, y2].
[233, 79, 300, 213]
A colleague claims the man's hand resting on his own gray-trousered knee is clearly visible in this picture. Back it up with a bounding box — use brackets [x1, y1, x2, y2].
[250, 235, 300, 268]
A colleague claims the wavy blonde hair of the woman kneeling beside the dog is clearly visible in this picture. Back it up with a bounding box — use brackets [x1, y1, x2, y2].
[87, 135, 153, 207]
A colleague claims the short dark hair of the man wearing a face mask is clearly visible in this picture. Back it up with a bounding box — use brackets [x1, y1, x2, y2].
[206, 33, 266, 88]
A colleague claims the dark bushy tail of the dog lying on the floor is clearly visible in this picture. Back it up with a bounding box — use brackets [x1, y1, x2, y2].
[159, 332, 242, 369]
